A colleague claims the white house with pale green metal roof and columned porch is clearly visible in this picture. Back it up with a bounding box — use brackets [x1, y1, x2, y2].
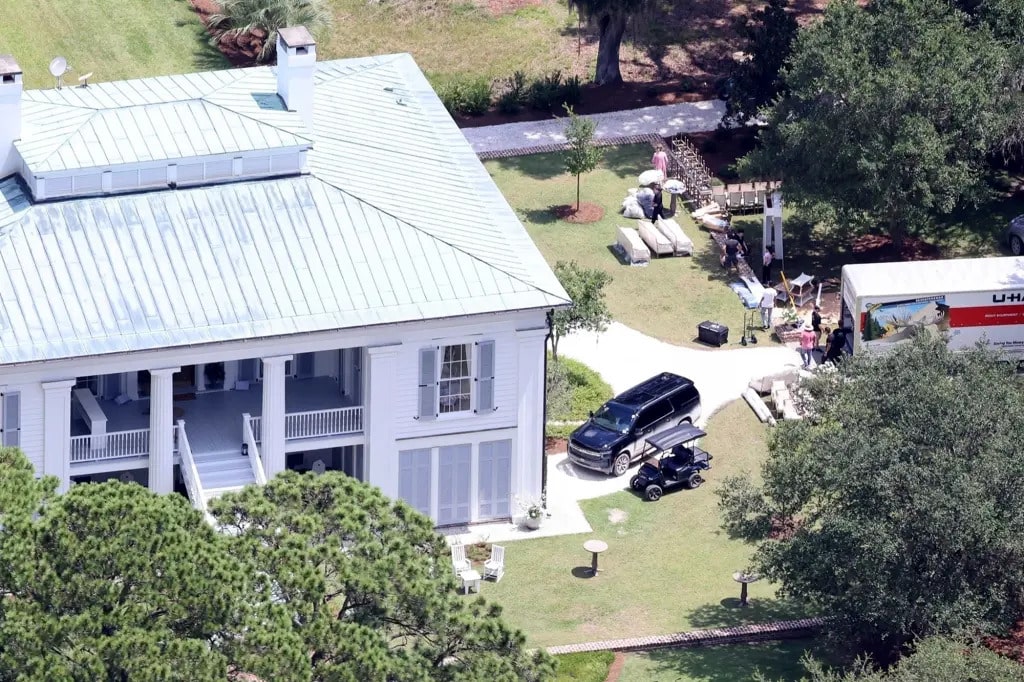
[0, 28, 567, 525]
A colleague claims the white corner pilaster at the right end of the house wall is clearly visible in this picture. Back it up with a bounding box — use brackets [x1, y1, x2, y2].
[512, 329, 548, 498]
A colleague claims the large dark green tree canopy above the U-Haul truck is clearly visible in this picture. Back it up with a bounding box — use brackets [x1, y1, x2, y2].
[740, 0, 1015, 243]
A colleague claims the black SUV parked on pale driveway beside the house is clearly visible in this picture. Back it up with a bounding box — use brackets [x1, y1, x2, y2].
[569, 372, 700, 476]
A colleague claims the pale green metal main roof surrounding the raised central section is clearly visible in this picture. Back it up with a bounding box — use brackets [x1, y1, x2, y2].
[0, 54, 568, 364]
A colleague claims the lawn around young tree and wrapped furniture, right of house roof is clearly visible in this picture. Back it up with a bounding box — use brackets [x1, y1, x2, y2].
[485, 144, 743, 346]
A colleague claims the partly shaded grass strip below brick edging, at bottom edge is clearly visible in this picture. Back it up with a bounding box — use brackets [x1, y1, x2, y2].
[618, 640, 814, 682]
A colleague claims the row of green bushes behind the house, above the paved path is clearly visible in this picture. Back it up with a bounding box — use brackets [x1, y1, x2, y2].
[434, 71, 583, 116]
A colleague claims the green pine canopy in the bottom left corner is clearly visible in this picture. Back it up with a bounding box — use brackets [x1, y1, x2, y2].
[0, 449, 251, 682]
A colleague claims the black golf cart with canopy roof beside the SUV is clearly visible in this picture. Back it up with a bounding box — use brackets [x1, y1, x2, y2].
[630, 423, 712, 502]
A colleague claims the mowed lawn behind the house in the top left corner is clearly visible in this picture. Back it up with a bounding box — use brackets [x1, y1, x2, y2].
[0, 0, 228, 88]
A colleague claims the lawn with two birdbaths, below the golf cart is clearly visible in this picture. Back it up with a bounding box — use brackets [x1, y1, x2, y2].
[482, 400, 804, 646]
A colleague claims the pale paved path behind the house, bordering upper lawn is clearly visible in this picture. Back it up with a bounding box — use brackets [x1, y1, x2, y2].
[462, 99, 725, 156]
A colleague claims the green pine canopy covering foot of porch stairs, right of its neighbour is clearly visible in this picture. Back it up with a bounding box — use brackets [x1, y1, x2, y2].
[212, 472, 553, 682]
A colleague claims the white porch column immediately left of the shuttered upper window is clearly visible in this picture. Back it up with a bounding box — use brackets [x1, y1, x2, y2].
[362, 345, 399, 498]
